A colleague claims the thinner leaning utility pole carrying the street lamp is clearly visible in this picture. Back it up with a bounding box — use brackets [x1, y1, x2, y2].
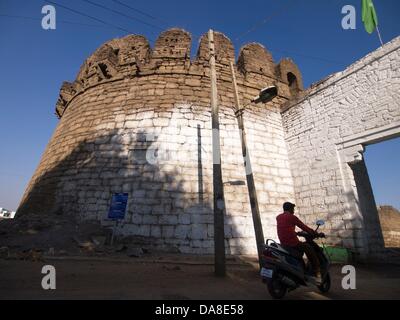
[231, 61, 264, 268]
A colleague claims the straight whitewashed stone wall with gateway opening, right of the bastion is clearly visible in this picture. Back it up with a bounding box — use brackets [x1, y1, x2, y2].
[282, 37, 400, 255]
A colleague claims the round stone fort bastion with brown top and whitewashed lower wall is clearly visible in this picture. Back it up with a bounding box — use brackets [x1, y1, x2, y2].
[18, 29, 302, 253]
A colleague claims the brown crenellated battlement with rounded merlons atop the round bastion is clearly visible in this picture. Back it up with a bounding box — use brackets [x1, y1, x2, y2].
[56, 28, 303, 118]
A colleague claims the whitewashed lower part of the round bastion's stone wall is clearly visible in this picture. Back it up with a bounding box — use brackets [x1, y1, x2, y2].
[104, 104, 294, 254]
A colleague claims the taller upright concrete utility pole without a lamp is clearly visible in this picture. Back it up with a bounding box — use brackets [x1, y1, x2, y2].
[208, 29, 226, 277]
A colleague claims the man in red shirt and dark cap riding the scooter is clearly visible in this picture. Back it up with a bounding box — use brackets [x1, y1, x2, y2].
[276, 202, 323, 283]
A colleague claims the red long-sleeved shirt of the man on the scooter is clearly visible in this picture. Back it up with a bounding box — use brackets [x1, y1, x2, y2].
[276, 211, 315, 247]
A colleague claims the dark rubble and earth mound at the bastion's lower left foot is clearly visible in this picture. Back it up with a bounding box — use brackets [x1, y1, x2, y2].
[0, 214, 149, 261]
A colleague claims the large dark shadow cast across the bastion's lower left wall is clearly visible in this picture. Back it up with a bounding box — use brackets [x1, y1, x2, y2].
[16, 128, 244, 254]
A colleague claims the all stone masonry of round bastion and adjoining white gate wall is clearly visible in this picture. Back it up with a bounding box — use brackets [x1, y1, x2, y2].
[18, 29, 400, 256]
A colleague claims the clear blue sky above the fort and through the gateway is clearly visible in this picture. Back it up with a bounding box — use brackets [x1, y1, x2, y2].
[0, 0, 400, 209]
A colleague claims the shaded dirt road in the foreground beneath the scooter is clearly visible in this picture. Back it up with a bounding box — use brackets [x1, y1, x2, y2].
[0, 258, 400, 300]
